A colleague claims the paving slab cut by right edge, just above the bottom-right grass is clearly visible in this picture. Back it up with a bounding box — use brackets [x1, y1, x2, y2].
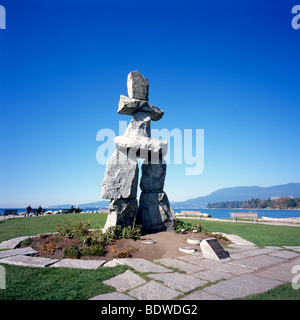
[257, 258, 300, 282]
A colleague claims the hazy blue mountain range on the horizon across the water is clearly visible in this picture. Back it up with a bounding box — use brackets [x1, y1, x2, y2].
[54, 183, 300, 209]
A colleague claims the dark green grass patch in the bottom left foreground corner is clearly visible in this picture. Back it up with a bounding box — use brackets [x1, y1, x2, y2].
[0, 264, 128, 300]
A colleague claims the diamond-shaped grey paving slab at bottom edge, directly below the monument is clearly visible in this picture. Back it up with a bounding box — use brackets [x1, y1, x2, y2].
[128, 280, 181, 300]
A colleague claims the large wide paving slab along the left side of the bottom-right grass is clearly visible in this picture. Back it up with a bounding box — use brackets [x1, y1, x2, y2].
[203, 274, 282, 299]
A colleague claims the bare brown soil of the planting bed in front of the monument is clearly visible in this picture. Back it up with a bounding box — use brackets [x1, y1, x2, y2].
[21, 231, 231, 261]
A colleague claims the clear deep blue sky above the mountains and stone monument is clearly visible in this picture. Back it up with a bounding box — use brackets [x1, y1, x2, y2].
[0, 0, 300, 207]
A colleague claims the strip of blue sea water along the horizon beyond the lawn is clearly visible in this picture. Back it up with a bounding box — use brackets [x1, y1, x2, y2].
[0, 208, 300, 219]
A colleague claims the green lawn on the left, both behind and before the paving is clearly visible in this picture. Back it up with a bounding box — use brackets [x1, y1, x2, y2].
[0, 213, 128, 300]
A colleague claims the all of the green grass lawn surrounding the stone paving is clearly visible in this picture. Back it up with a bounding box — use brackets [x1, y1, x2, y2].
[0, 213, 300, 300]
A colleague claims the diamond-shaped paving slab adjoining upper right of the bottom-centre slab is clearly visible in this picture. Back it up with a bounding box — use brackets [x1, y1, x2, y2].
[148, 272, 207, 292]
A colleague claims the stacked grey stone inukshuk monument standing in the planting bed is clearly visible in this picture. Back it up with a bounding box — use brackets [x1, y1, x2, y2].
[102, 71, 175, 233]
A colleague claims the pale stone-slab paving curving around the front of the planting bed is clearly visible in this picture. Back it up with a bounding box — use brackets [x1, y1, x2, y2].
[0, 235, 300, 300]
